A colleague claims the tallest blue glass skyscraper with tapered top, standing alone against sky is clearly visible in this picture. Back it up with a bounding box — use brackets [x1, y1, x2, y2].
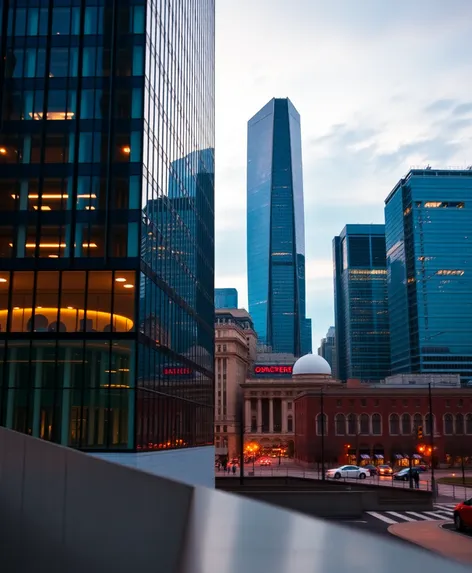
[247, 99, 311, 356]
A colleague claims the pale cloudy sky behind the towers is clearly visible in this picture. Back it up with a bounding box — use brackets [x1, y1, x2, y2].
[215, 0, 472, 352]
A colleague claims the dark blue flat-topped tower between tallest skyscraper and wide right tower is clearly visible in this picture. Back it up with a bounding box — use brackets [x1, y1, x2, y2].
[333, 225, 390, 381]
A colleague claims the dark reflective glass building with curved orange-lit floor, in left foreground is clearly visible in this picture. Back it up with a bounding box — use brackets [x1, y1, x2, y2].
[0, 0, 214, 451]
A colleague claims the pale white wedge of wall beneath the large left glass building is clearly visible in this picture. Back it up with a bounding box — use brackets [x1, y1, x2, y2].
[92, 446, 215, 488]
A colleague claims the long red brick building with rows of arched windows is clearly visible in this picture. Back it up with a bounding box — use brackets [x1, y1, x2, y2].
[293, 355, 472, 466]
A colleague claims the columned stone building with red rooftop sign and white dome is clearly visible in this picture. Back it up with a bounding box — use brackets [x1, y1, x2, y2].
[242, 354, 332, 455]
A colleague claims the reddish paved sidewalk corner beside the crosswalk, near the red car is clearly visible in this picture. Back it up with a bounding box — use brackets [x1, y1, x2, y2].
[388, 521, 472, 565]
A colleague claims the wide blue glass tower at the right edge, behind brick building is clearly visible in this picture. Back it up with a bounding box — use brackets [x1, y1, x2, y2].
[385, 169, 472, 381]
